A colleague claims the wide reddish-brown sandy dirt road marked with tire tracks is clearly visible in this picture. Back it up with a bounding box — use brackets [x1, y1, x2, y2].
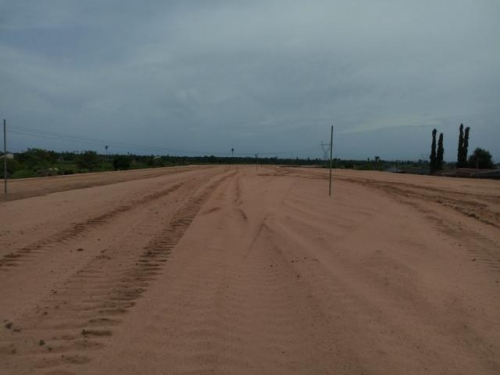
[0, 166, 500, 375]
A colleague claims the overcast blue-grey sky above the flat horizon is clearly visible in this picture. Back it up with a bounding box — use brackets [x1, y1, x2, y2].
[0, 0, 500, 162]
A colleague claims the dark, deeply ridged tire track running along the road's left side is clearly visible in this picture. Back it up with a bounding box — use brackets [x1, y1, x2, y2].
[0, 174, 231, 374]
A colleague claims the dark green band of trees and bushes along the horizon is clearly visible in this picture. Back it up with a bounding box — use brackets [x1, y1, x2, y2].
[2, 138, 493, 179]
